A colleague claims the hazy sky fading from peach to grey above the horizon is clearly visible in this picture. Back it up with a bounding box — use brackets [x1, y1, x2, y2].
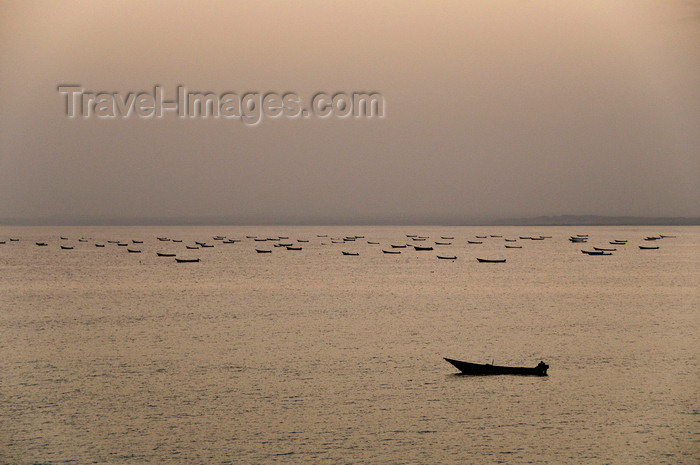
[0, 0, 700, 224]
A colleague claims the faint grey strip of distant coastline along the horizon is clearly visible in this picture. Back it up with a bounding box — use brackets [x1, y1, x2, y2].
[0, 215, 700, 226]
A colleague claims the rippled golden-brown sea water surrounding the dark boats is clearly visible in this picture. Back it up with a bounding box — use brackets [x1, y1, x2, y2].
[0, 226, 700, 465]
